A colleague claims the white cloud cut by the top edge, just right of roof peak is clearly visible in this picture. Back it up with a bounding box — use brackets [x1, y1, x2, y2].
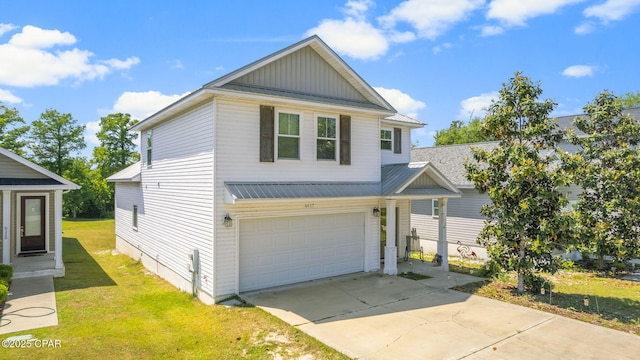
[378, 0, 484, 39]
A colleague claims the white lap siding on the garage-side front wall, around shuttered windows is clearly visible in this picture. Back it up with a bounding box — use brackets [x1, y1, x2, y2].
[215, 100, 380, 296]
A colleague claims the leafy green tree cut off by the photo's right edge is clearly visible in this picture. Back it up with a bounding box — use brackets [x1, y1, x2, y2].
[562, 91, 640, 267]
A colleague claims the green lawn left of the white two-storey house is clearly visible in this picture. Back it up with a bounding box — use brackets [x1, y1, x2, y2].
[1, 220, 346, 359]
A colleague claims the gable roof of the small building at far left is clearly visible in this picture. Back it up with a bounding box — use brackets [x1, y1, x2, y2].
[0, 148, 80, 190]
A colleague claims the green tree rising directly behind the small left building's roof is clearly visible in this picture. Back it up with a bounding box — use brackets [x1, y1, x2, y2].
[29, 109, 87, 175]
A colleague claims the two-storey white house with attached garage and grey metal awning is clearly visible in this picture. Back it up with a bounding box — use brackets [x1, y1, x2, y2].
[109, 36, 461, 303]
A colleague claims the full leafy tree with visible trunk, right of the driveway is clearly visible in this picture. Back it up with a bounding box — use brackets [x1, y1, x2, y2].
[465, 73, 571, 293]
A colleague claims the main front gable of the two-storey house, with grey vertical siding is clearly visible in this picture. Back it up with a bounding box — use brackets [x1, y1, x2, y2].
[131, 35, 396, 131]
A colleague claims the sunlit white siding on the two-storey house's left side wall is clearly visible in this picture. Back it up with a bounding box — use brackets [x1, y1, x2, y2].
[131, 102, 214, 295]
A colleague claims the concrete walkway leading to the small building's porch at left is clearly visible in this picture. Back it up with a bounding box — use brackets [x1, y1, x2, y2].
[0, 276, 58, 334]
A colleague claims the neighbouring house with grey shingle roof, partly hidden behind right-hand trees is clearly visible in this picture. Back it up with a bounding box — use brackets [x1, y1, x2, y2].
[411, 108, 640, 259]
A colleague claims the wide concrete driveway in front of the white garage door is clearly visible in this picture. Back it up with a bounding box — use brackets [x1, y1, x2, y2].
[241, 263, 640, 359]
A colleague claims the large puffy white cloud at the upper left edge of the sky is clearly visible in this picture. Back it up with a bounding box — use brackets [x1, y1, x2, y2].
[0, 25, 140, 87]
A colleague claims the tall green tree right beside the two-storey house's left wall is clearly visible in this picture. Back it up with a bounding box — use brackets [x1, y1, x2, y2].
[93, 113, 140, 177]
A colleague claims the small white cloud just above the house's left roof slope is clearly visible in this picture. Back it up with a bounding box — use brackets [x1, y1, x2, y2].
[109, 91, 189, 120]
